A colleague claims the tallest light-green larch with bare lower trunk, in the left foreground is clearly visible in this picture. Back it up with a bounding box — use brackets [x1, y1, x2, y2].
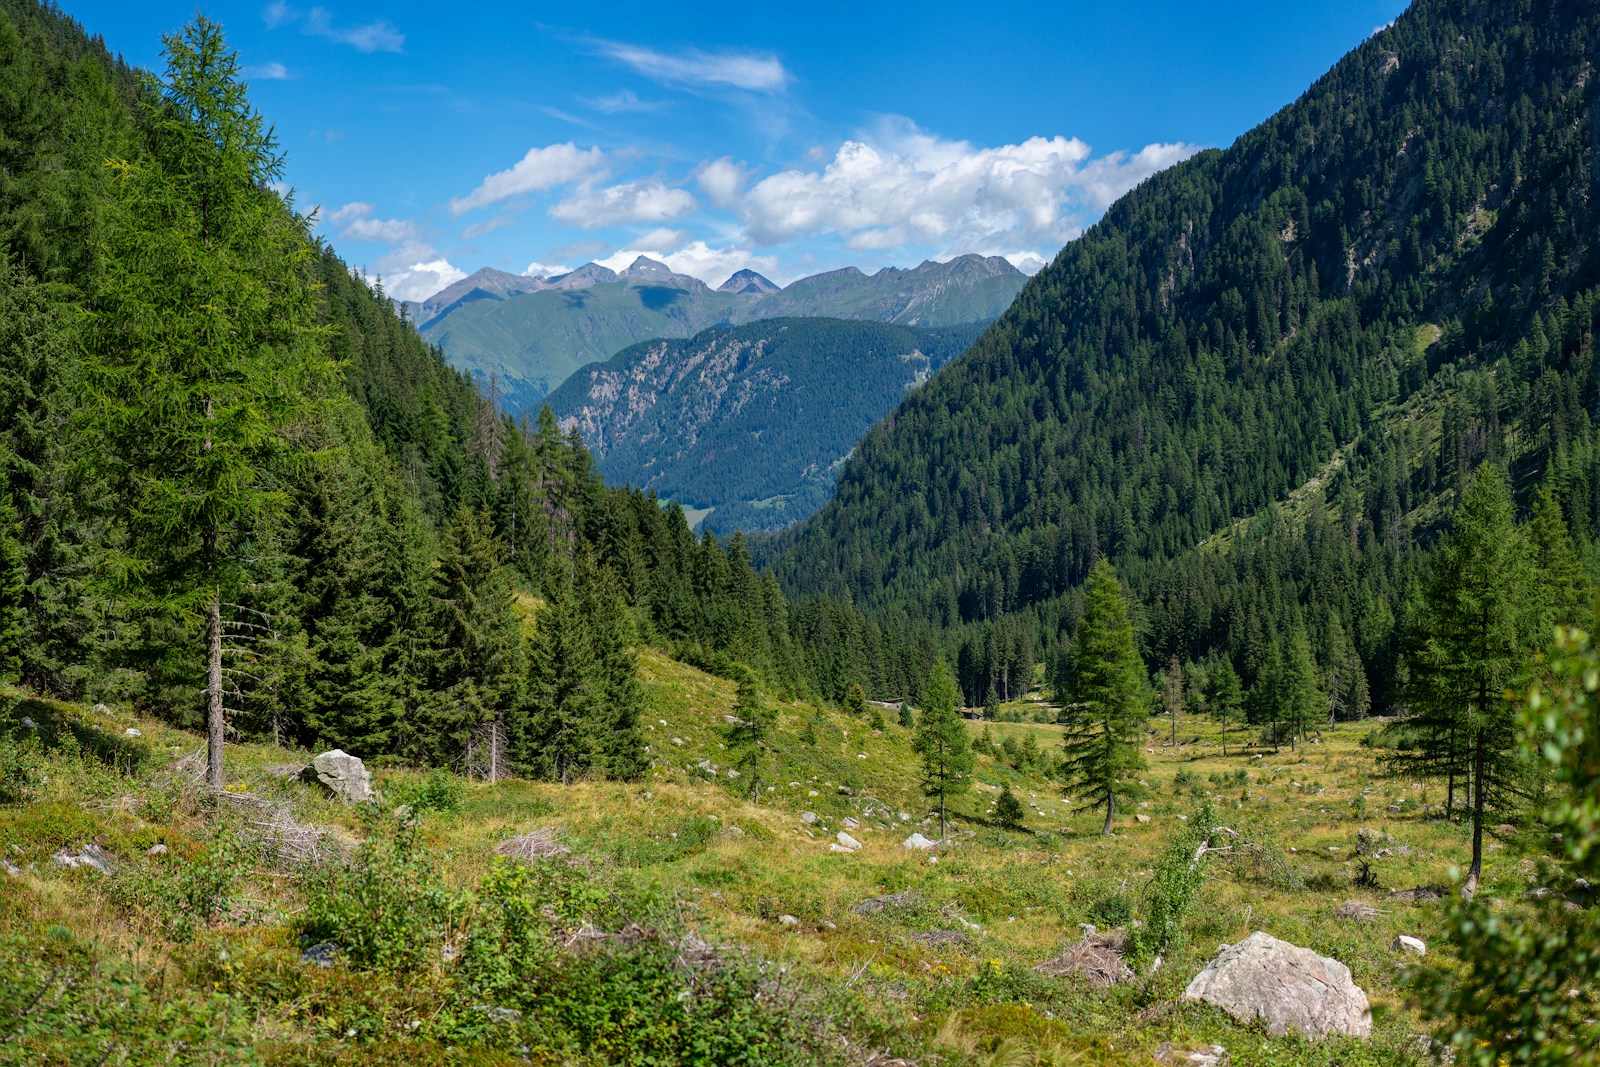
[88, 16, 336, 789]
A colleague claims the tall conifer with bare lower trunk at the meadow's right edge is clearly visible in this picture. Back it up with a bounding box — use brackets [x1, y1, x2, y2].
[1402, 464, 1544, 899]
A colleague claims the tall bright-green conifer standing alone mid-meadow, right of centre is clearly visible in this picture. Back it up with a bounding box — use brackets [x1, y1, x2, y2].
[1062, 557, 1149, 835]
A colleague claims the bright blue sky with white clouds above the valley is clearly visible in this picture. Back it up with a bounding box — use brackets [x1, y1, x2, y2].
[62, 0, 1405, 299]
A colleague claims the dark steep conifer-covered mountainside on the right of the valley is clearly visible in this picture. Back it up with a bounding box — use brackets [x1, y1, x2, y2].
[771, 0, 1600, 705]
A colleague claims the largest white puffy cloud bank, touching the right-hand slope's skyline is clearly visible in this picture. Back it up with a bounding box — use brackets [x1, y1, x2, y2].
[732, 118, 1195, 251]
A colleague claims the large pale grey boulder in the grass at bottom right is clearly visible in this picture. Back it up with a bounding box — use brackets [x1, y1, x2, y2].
[1184, 931, 1373, 1037]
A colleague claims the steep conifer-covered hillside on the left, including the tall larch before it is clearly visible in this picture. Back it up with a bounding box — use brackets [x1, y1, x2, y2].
[0, 0, 915, 777]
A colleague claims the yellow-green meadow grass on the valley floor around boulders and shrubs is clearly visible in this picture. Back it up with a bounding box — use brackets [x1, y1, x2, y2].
[0, 662, 1534, 1064]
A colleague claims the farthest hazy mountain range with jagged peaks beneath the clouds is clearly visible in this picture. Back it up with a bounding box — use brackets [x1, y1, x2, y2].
[405, 254, 1027, 413]
